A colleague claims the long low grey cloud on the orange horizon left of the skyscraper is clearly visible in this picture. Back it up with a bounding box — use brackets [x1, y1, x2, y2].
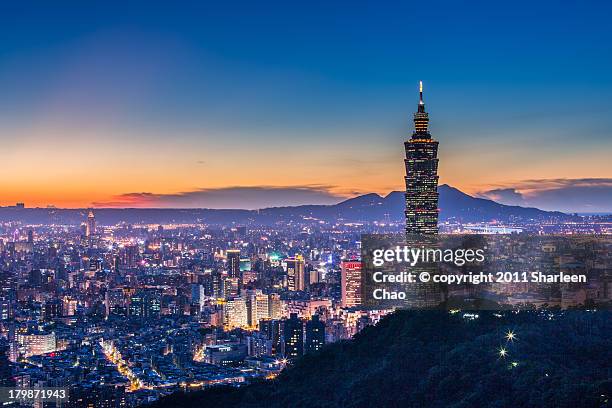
[92, 185, 346, 210]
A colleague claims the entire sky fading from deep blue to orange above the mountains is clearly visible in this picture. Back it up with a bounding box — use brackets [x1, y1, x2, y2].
[0, 1, 612, 211]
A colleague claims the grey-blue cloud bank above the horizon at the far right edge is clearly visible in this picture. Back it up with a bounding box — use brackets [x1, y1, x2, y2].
[478, 178, 612, 213]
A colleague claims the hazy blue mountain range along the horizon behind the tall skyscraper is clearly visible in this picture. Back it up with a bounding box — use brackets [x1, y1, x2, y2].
[0, 184, 572, 225]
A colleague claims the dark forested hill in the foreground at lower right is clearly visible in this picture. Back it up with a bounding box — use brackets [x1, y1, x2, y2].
[155, 311, 612, 408]
